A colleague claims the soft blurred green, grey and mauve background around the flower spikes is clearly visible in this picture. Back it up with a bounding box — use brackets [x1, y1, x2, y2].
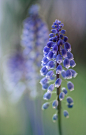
[0, 0, 86, 135]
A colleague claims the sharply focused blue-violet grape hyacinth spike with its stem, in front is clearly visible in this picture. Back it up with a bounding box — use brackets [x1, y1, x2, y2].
[40, 20, 77, 135]
